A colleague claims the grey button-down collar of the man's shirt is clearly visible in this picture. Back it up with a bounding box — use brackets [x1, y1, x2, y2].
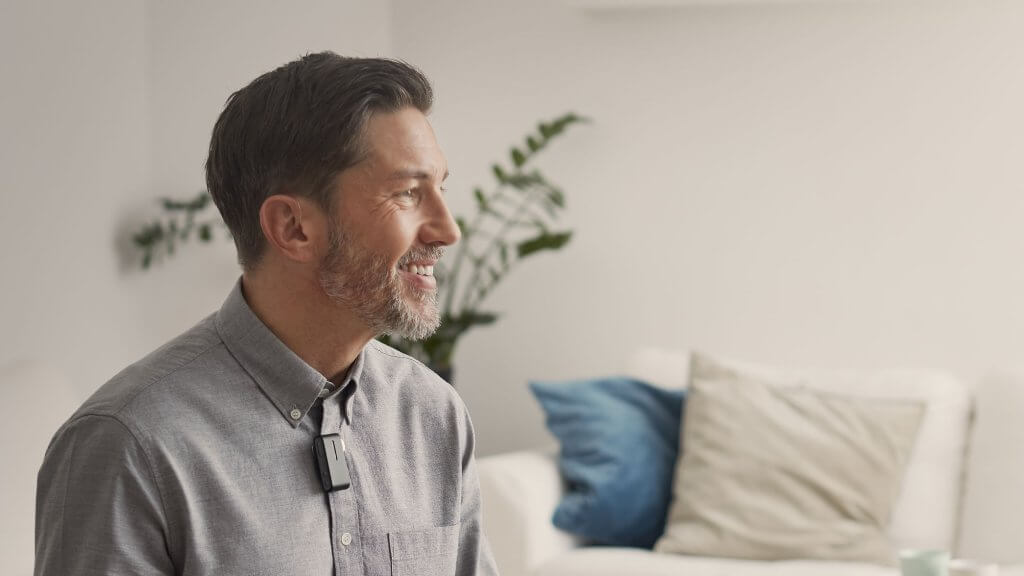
[216, 279, 366, 427]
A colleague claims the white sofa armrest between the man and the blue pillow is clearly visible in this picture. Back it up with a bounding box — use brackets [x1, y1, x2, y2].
[477, 451, 581, 576]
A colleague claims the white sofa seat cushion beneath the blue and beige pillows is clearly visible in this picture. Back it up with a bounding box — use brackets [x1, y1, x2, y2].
[532, 547, 899, 576]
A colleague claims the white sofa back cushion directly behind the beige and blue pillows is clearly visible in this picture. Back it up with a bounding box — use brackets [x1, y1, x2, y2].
[630, 348, 972, 549]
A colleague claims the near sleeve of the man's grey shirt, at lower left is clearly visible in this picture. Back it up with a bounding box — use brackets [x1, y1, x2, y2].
[35, 415, 175, 576]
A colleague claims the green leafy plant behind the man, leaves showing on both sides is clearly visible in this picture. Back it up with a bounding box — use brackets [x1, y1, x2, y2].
[133, 113, 587, 377]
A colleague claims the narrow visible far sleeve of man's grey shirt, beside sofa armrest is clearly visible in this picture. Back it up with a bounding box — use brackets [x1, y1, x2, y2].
[456, 408, 498, 576]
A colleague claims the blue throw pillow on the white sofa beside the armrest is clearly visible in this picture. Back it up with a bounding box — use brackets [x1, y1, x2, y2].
[529, 378, 685, 548]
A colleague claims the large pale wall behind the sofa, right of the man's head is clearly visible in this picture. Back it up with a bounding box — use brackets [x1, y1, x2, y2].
[394, 0, 1024, 454]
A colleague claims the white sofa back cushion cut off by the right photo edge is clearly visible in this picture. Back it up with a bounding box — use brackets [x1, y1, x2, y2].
[957, 372, 1024, 564]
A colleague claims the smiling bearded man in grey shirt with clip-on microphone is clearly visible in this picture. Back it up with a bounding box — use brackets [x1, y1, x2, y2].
[36, 52, 497, 576]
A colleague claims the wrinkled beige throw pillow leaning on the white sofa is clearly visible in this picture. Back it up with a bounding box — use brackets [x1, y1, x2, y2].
[654, 355, 925, 565]
